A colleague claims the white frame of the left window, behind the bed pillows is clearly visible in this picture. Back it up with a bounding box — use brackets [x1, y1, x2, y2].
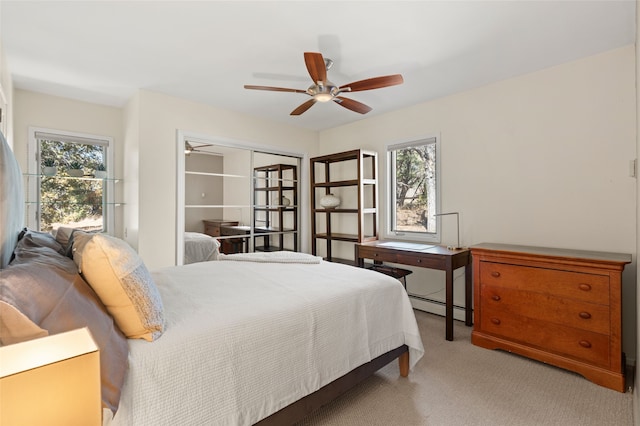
[25, 127, 115, 235]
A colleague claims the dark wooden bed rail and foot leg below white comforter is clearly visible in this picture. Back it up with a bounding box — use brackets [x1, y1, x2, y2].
[256, 345, 409, 426]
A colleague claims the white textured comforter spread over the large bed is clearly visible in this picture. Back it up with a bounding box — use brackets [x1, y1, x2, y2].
[104, 261, 424, 426]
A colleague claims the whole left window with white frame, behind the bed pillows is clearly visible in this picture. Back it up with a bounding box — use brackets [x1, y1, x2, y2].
[27, 129, 114, 232]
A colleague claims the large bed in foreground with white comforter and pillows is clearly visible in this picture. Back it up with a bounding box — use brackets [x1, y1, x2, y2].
[0, 131, 424, 426]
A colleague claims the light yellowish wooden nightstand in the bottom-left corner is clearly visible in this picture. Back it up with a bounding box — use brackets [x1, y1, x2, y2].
[0, 328, 102, 425]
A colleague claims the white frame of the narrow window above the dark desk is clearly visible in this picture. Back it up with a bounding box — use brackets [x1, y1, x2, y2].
[383, 134, 442, 244]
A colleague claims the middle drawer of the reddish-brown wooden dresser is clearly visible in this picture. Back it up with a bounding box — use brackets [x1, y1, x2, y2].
[480, 285, 611, 334]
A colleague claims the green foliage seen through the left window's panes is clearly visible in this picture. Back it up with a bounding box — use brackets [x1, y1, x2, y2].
[40, 140, 104, 231]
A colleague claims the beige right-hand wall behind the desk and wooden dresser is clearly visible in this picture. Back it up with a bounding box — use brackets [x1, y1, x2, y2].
[320, 46, 637, 358]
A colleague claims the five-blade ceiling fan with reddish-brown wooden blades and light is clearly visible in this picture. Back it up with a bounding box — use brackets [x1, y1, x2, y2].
[244, 52, 404, 115]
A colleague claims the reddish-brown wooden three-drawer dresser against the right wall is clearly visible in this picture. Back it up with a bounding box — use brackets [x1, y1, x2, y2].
[471, 243, 631, 392]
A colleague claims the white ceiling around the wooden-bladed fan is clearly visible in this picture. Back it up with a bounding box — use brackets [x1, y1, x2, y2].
[0, 0, 635, 130]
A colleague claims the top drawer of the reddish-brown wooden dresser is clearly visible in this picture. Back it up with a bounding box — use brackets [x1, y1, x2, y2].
[479, 262, 609, 305]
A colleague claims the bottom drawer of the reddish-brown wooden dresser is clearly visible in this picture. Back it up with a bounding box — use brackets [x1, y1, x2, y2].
[480, 307, 610, 368]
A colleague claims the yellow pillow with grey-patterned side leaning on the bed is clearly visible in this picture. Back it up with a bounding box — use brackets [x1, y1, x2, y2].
[73, 231, 164, 341]
